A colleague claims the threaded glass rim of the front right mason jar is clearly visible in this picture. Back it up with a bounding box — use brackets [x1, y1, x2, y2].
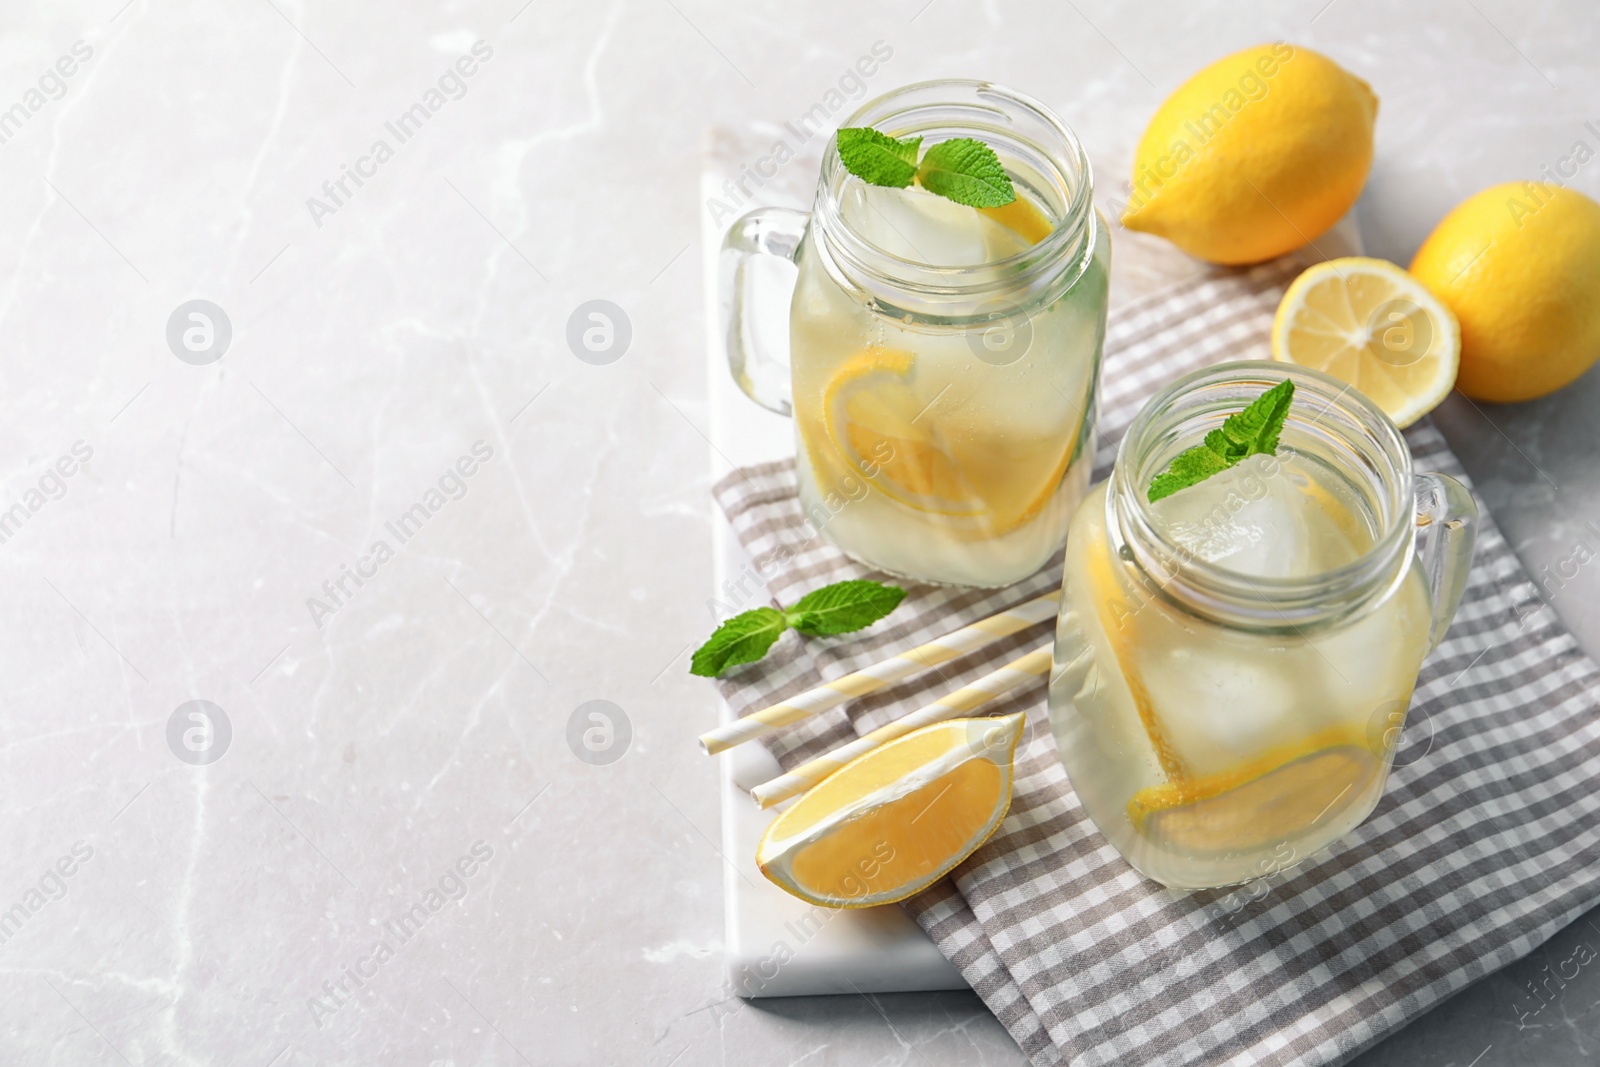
[1107, 360, 1416, 629]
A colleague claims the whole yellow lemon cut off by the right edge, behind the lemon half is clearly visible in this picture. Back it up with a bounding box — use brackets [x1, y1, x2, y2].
[1411, 181, 1600, 403]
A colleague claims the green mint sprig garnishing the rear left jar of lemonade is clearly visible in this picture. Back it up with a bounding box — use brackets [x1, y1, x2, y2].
[838, 126, 1016, 208]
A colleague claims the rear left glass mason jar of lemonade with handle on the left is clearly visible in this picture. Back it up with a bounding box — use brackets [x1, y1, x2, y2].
[722, 80, 1110, 585]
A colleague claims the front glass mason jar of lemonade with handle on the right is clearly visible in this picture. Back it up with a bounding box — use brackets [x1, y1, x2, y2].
[1050, 362, 1477, 889]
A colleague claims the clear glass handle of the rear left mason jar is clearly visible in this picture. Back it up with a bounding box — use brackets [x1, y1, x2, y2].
[717, 208, 811, 414]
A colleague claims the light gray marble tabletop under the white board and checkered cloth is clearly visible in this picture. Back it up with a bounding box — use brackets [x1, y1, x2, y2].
[0, 0, 1600, 1067]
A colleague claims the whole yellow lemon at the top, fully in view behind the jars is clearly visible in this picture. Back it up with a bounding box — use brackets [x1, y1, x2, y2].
[1122, 42, 1378, 264]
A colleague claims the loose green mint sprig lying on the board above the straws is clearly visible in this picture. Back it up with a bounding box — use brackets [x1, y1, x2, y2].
[690, 579, 906, 678]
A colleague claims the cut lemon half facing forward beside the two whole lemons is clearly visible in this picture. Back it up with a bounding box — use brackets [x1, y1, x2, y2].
[1272, 256, 1461, 429]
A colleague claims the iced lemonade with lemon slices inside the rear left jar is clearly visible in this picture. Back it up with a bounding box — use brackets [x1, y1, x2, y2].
[790, 182, 1110, 585]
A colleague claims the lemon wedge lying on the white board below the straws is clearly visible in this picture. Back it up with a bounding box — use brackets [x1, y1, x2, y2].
[755, 713, 1024, 907]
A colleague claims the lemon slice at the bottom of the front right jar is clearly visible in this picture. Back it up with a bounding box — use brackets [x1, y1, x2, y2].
[1128, 726, 1379, 854]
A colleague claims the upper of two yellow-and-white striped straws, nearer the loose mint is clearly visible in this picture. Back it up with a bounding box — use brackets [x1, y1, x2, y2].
[701, 589, 1061, 755]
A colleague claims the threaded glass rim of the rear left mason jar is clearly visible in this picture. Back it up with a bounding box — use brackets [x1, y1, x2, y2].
[813, 78, 1094, 296]
